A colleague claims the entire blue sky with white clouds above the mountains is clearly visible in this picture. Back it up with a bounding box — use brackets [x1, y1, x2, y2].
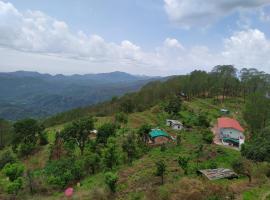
[0, 0, 270, 76]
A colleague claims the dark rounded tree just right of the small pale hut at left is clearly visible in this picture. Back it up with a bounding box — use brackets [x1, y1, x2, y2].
[96, 123, 117, 145]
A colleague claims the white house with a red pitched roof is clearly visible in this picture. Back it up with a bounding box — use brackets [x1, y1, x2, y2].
[218, 117, 245, 148]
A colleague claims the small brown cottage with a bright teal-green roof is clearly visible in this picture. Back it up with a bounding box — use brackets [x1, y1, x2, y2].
[149, 129, 172, 144]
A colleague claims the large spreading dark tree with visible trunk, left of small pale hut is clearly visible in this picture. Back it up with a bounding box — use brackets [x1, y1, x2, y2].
[61, 117, 94, 155]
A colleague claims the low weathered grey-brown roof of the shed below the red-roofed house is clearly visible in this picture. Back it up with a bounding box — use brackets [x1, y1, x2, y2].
[198, 168, 238, 180]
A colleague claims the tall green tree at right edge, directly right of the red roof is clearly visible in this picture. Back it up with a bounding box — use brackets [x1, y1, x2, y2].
[243, 93, 270, 133]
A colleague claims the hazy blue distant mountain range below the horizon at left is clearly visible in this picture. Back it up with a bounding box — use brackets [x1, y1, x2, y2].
[0, 71, 160, 120]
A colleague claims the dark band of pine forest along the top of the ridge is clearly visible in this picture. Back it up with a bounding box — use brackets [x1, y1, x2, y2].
[44, 66, 270, 126]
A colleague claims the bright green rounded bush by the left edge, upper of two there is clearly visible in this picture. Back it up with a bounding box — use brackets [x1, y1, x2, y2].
[2, 163, 24, 181]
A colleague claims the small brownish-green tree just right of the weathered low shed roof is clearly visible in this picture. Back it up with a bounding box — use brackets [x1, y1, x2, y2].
[232, 159, 252, 183]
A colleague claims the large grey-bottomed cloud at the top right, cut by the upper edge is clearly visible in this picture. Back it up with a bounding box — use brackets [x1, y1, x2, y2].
[164, 0, 270, 28]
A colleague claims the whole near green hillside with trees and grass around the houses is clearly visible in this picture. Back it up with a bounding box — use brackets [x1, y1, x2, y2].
[0, 65, 270, 200]
